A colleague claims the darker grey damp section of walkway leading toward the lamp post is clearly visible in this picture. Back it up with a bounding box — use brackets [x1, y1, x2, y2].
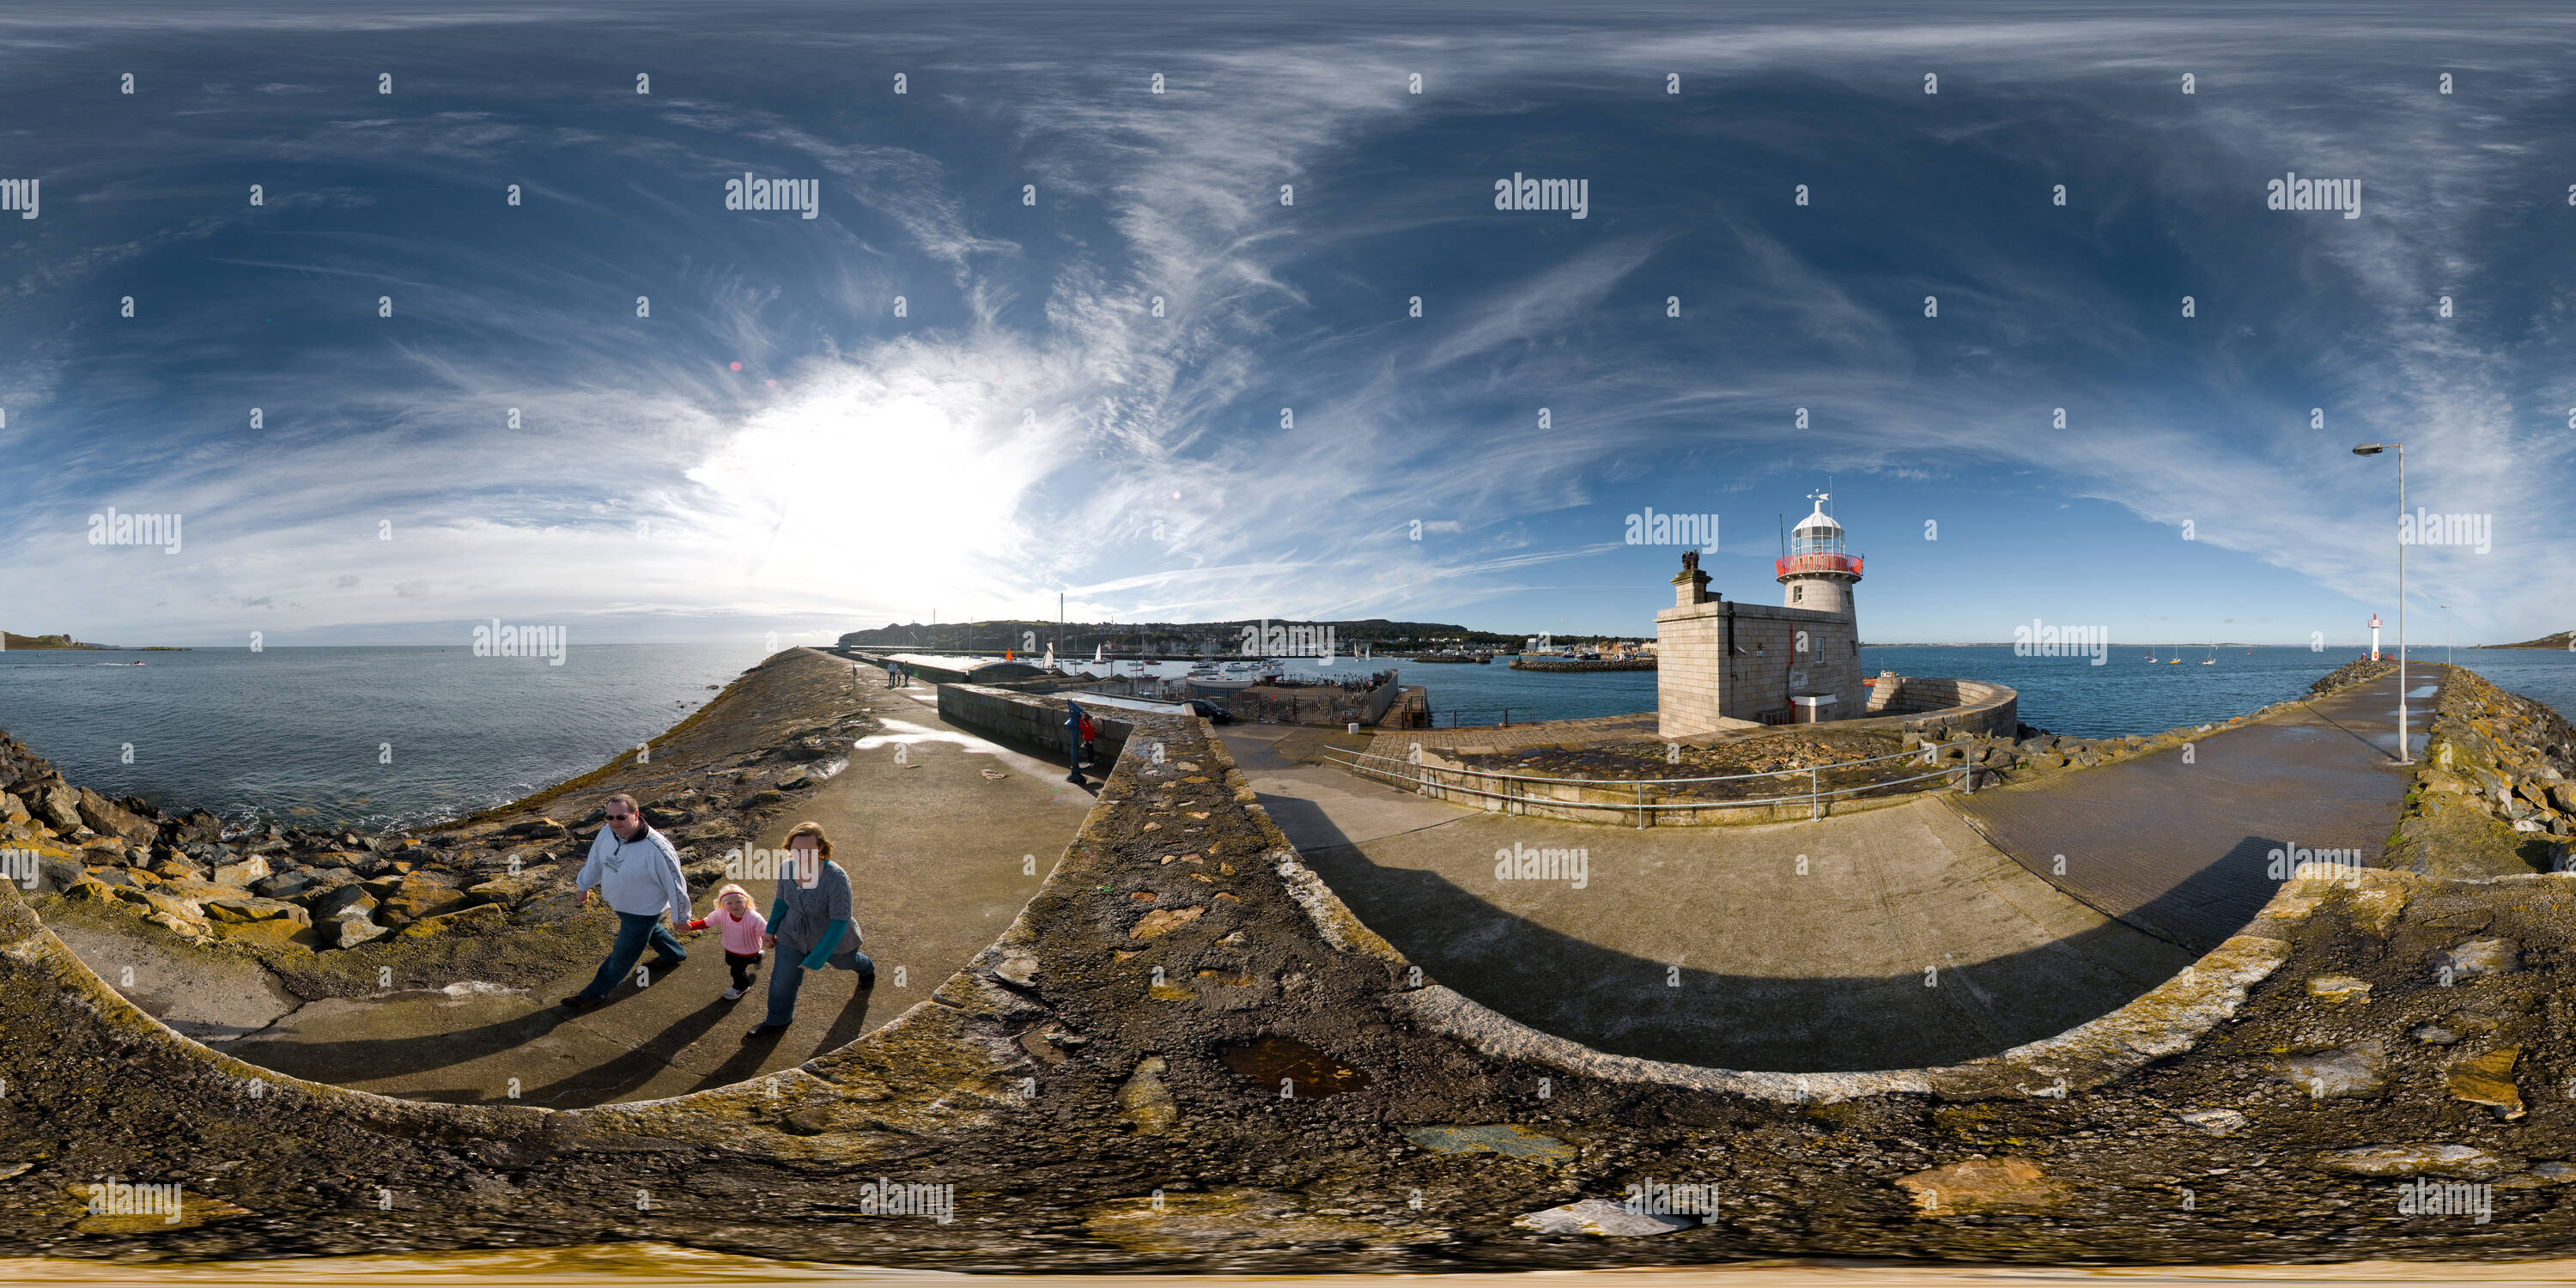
[1950, 672, 2434, 953]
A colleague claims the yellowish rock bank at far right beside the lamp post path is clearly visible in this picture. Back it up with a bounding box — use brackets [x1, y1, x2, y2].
[2383, 665, 2576, 878]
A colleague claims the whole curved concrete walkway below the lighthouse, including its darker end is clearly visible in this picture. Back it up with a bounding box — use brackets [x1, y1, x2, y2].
[1224, 680, 2432, 1072]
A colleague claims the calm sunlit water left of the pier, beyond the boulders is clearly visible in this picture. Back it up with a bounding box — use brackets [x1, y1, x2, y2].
[0, 641, 762, 827]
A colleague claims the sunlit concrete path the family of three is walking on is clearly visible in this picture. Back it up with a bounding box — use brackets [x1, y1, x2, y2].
[219, 672, 1092, 1108]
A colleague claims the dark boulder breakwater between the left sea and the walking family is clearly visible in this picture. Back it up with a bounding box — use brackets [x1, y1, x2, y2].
[0, 649, 876, 999]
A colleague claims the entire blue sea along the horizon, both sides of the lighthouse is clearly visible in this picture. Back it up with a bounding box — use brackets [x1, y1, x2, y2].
[0, 641, 2576, 829]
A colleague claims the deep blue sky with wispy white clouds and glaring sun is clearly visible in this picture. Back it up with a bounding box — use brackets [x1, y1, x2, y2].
[0, 3, 2576, 647]
